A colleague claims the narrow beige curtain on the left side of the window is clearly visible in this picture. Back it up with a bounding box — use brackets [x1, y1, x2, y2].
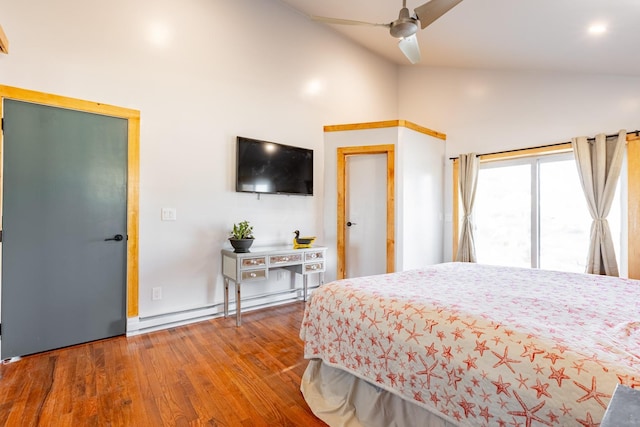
[456, 153, 480, 262]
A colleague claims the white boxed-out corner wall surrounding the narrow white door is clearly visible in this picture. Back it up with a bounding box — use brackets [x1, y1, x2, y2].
[324, 126, 446, 280]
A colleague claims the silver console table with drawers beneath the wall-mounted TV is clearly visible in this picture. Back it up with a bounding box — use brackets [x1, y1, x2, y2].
[222, 245, 327, 326]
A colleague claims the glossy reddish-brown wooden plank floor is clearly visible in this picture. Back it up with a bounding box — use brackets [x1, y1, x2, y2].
[0, 303, 325, 427]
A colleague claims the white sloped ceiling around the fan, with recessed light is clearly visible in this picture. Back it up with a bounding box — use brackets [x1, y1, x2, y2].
[281, 0, 640, 76]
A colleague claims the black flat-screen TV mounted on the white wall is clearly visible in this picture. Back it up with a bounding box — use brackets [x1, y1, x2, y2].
[236, 136, 313, 196]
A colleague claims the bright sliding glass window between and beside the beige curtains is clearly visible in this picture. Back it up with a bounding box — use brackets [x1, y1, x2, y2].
[473, 153, 621, 272]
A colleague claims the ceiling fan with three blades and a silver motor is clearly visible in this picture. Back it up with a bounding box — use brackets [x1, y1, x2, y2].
[311, 0, 462, 64]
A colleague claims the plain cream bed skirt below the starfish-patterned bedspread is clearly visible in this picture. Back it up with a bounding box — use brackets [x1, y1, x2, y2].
[300, 359, 458, 427]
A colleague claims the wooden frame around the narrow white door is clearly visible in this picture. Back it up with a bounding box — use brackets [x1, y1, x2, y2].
[336, 144, 395, 279]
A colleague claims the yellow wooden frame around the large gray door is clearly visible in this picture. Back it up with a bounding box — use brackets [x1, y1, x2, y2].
[0, 85, 140, 317]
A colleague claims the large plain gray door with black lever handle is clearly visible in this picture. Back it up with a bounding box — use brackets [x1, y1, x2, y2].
[0, 100, 127, 359]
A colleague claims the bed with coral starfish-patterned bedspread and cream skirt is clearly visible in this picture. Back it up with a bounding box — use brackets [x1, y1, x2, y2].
[300, 263, 640, 427]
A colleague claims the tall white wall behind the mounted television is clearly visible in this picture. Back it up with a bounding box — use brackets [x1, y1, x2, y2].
[0, 0, 397, 317]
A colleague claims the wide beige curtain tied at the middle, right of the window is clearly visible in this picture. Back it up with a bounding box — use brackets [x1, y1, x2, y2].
[571, 130, 627, 276]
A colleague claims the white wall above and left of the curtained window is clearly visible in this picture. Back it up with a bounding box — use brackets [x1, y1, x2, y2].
[398, 67, 640, 260]
